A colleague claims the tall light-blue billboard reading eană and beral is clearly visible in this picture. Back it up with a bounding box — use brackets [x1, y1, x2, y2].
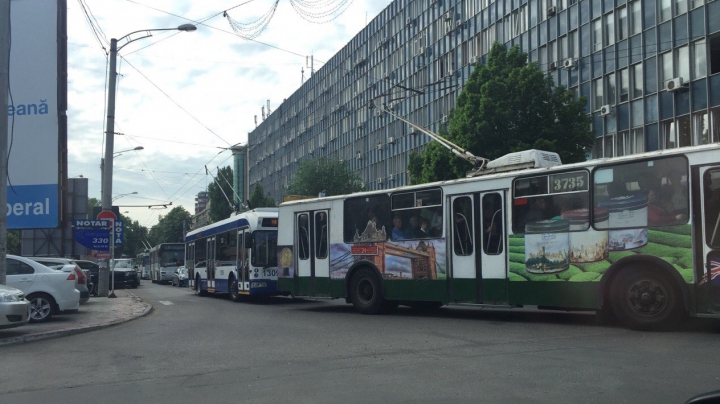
[7, 0, 60, 229]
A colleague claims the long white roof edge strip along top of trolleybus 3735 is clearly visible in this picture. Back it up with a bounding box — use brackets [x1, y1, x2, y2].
[280, 143, 720, 207]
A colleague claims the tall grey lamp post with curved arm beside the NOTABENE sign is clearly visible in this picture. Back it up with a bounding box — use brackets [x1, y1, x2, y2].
[98, 24, 197, 296]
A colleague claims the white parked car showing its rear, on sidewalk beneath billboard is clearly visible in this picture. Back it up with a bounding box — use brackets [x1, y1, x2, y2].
[7, 254, 80, 323]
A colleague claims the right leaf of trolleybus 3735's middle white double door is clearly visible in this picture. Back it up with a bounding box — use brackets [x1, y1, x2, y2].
[477, 191, 508, 304]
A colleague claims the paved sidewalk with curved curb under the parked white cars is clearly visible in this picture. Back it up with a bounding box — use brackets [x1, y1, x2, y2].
[0, 289, 152, 347]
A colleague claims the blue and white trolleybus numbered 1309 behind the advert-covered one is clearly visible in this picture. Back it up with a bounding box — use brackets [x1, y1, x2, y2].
[185, 208, 278, 301]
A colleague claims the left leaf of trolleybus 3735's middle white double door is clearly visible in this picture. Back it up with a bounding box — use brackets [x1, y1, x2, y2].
[447, 194, 482, 301]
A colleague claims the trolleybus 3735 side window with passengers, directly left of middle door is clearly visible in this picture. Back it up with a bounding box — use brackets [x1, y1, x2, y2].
[390, 189, 442, 240]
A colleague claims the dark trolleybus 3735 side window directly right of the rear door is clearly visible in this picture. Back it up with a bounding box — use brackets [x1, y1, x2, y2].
[343, 194, 392, 243]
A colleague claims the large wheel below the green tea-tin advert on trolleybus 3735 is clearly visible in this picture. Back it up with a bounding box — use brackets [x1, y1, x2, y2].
[610, 267, 684, 330]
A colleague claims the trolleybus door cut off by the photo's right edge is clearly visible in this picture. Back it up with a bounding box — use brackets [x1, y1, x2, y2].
[693, 167, 720, 313]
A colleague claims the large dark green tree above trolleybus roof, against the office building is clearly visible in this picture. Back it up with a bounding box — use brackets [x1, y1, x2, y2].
[408, 42, 595, 184]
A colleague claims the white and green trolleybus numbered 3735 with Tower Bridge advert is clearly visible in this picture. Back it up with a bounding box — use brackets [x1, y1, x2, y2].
[278, 144, 720, 329]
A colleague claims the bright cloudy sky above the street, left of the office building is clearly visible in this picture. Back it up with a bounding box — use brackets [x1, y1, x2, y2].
[67, 0, 390, 228]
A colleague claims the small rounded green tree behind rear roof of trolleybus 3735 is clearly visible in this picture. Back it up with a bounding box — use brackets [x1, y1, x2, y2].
[287, 158, 363, 196]
